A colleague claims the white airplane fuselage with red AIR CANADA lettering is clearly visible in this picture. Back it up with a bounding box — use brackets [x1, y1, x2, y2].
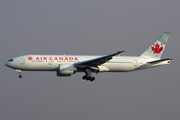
[6, 55, 169, 72]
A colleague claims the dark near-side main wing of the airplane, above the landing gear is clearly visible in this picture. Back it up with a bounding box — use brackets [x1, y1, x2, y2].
[74, 51, 124, 68]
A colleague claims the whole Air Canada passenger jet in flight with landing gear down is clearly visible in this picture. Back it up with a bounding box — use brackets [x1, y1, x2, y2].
[5, 32, 172, 82]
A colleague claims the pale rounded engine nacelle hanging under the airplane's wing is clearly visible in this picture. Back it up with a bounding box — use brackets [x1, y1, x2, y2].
[57, 63, 77, 76]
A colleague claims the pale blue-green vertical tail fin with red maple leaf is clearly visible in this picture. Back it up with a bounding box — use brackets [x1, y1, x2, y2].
[140, 32, 170, 59]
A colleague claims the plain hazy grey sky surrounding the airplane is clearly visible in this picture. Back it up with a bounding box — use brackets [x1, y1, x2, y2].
[0, 0, 180, 120]
